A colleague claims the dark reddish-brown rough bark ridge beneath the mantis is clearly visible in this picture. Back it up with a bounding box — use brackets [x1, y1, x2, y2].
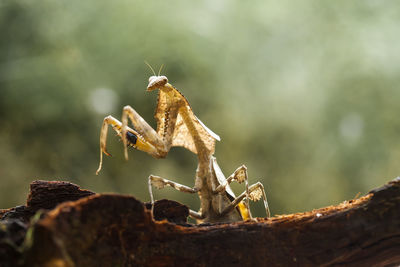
[0, 179, 400, 266]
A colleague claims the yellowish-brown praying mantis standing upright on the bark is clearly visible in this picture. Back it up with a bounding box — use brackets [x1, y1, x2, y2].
[96, 71, 270, 223]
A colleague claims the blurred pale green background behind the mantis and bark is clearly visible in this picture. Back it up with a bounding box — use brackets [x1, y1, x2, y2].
[0, 0, 400, 216]
